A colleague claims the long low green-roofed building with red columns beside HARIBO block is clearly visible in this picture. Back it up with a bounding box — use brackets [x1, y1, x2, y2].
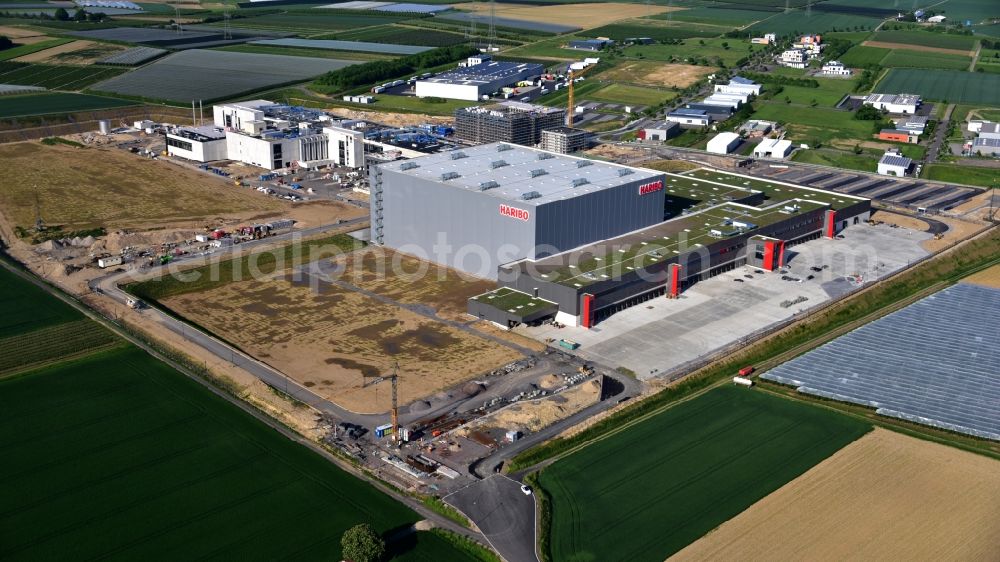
[468, 169, 871, 328]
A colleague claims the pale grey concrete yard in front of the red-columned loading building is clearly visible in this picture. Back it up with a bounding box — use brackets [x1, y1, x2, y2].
[517, 223, 930, 379]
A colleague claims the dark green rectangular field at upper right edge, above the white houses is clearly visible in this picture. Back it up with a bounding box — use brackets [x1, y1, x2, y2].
[875, 68, 1000, 107]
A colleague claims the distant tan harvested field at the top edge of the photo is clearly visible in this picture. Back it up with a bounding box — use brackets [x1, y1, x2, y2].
[456, 2, 682, 28]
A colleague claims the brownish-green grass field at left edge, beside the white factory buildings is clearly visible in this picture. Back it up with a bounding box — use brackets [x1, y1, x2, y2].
[0, 142, 288, 230]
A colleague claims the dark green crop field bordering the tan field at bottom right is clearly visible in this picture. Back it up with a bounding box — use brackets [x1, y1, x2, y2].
[539, 386, 871, 562]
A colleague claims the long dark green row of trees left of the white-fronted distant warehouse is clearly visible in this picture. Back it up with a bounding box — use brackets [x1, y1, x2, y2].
[316, 45, 479, 91]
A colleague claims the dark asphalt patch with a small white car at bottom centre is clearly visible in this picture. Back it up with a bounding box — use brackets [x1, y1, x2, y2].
[444, 474, 538, 562]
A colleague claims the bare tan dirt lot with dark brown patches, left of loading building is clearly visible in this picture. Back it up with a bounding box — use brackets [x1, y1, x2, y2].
[164, 274, 520, 413]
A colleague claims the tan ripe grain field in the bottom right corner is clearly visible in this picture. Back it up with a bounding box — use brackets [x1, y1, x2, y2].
[671, 429, 1000, 562]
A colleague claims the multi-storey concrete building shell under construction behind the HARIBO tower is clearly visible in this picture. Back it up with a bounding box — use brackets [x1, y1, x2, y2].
[455, 101, 566, 146]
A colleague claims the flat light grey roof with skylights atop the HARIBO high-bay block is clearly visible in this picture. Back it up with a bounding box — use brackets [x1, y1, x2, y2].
[380, 143, 662, 206]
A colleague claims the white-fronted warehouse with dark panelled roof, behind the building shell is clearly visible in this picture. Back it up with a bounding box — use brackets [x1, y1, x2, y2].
[415, 55, 545, 101]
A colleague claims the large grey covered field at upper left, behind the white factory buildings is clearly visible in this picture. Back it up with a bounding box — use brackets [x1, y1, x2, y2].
[91, 49, 354, 102]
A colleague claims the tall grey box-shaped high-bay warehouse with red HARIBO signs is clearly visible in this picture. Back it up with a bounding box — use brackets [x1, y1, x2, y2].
[370, 143, 665, 279]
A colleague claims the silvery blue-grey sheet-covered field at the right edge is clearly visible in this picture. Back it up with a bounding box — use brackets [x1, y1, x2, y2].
[762, 284, 1000, 440]
